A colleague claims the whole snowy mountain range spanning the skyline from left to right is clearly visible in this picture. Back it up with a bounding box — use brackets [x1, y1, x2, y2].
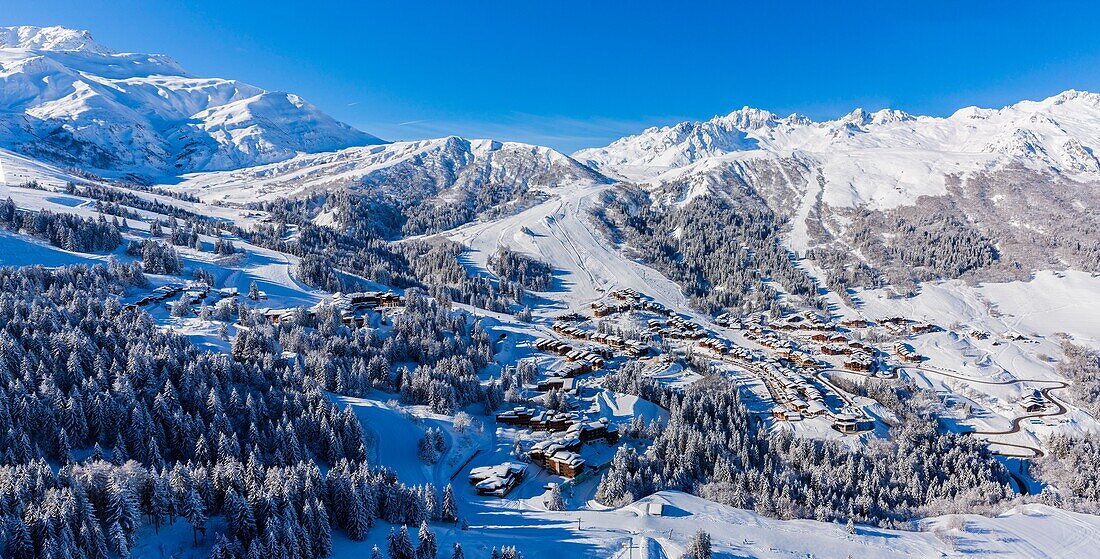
[0, 26, 1100, 283]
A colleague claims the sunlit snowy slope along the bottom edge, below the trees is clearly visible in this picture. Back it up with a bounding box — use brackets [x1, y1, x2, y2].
[321, 486, 1100, 559]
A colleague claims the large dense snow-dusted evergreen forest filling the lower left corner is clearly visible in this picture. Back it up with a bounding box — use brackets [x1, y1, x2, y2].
[0, 262, 468, 559]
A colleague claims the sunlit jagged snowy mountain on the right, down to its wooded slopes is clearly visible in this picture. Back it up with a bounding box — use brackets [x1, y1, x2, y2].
[573, 90, 1100, 261]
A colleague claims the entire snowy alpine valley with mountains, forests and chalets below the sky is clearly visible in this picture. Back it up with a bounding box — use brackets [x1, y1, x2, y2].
[0, 26, 1100, 559]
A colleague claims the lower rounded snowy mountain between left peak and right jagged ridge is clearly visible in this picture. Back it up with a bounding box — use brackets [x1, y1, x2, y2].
[173, 136, 609, 204]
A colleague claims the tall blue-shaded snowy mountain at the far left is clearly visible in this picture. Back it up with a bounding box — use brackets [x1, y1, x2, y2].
[0, 26, 382, 176]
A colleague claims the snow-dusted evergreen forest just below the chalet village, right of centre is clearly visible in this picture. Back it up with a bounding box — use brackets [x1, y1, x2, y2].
[597, 370, 1011, 528]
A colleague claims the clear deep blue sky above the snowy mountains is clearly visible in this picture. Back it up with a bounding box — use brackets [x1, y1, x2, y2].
[8, 0, 1100, 152]
